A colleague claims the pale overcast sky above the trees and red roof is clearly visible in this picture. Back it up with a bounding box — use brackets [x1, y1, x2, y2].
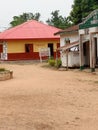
[0, 0, 73, 30]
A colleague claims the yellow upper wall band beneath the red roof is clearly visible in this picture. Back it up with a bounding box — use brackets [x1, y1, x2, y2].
[7, 40, 60, 53]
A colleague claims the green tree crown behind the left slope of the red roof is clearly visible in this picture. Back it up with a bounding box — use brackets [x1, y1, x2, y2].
[10, 13, 40, 27]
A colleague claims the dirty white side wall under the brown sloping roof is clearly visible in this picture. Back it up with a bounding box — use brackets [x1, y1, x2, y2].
[60, 32, 79, 67]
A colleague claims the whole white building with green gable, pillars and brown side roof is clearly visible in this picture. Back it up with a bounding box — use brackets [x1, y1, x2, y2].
[55, 9, 98, 72]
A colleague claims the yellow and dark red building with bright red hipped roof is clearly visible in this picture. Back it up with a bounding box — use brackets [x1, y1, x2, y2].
[0, 20, 60, 60]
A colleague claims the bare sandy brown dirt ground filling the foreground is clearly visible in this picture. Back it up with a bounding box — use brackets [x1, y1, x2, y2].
[0, 63, 98, 130]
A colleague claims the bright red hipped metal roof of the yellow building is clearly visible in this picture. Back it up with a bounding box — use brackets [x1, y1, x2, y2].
[0, 20, 60, 40]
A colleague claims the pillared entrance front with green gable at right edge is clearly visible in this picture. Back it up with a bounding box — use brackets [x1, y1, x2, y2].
[79, 9, 98, 71]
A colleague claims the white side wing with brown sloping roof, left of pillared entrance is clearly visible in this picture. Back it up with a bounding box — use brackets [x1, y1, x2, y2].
[55, 25, 79, 67]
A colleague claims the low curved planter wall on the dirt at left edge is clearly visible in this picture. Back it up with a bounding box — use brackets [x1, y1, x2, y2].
[0, 70, 13, 81]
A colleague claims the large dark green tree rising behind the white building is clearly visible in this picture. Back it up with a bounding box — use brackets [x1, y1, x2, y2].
[69, 0, 98, 24]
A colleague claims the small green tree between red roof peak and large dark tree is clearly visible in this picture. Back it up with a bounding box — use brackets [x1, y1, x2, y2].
[46, 10, 71, 29]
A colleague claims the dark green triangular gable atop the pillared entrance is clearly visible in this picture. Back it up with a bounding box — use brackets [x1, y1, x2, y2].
[79, 9, 98, 29]
